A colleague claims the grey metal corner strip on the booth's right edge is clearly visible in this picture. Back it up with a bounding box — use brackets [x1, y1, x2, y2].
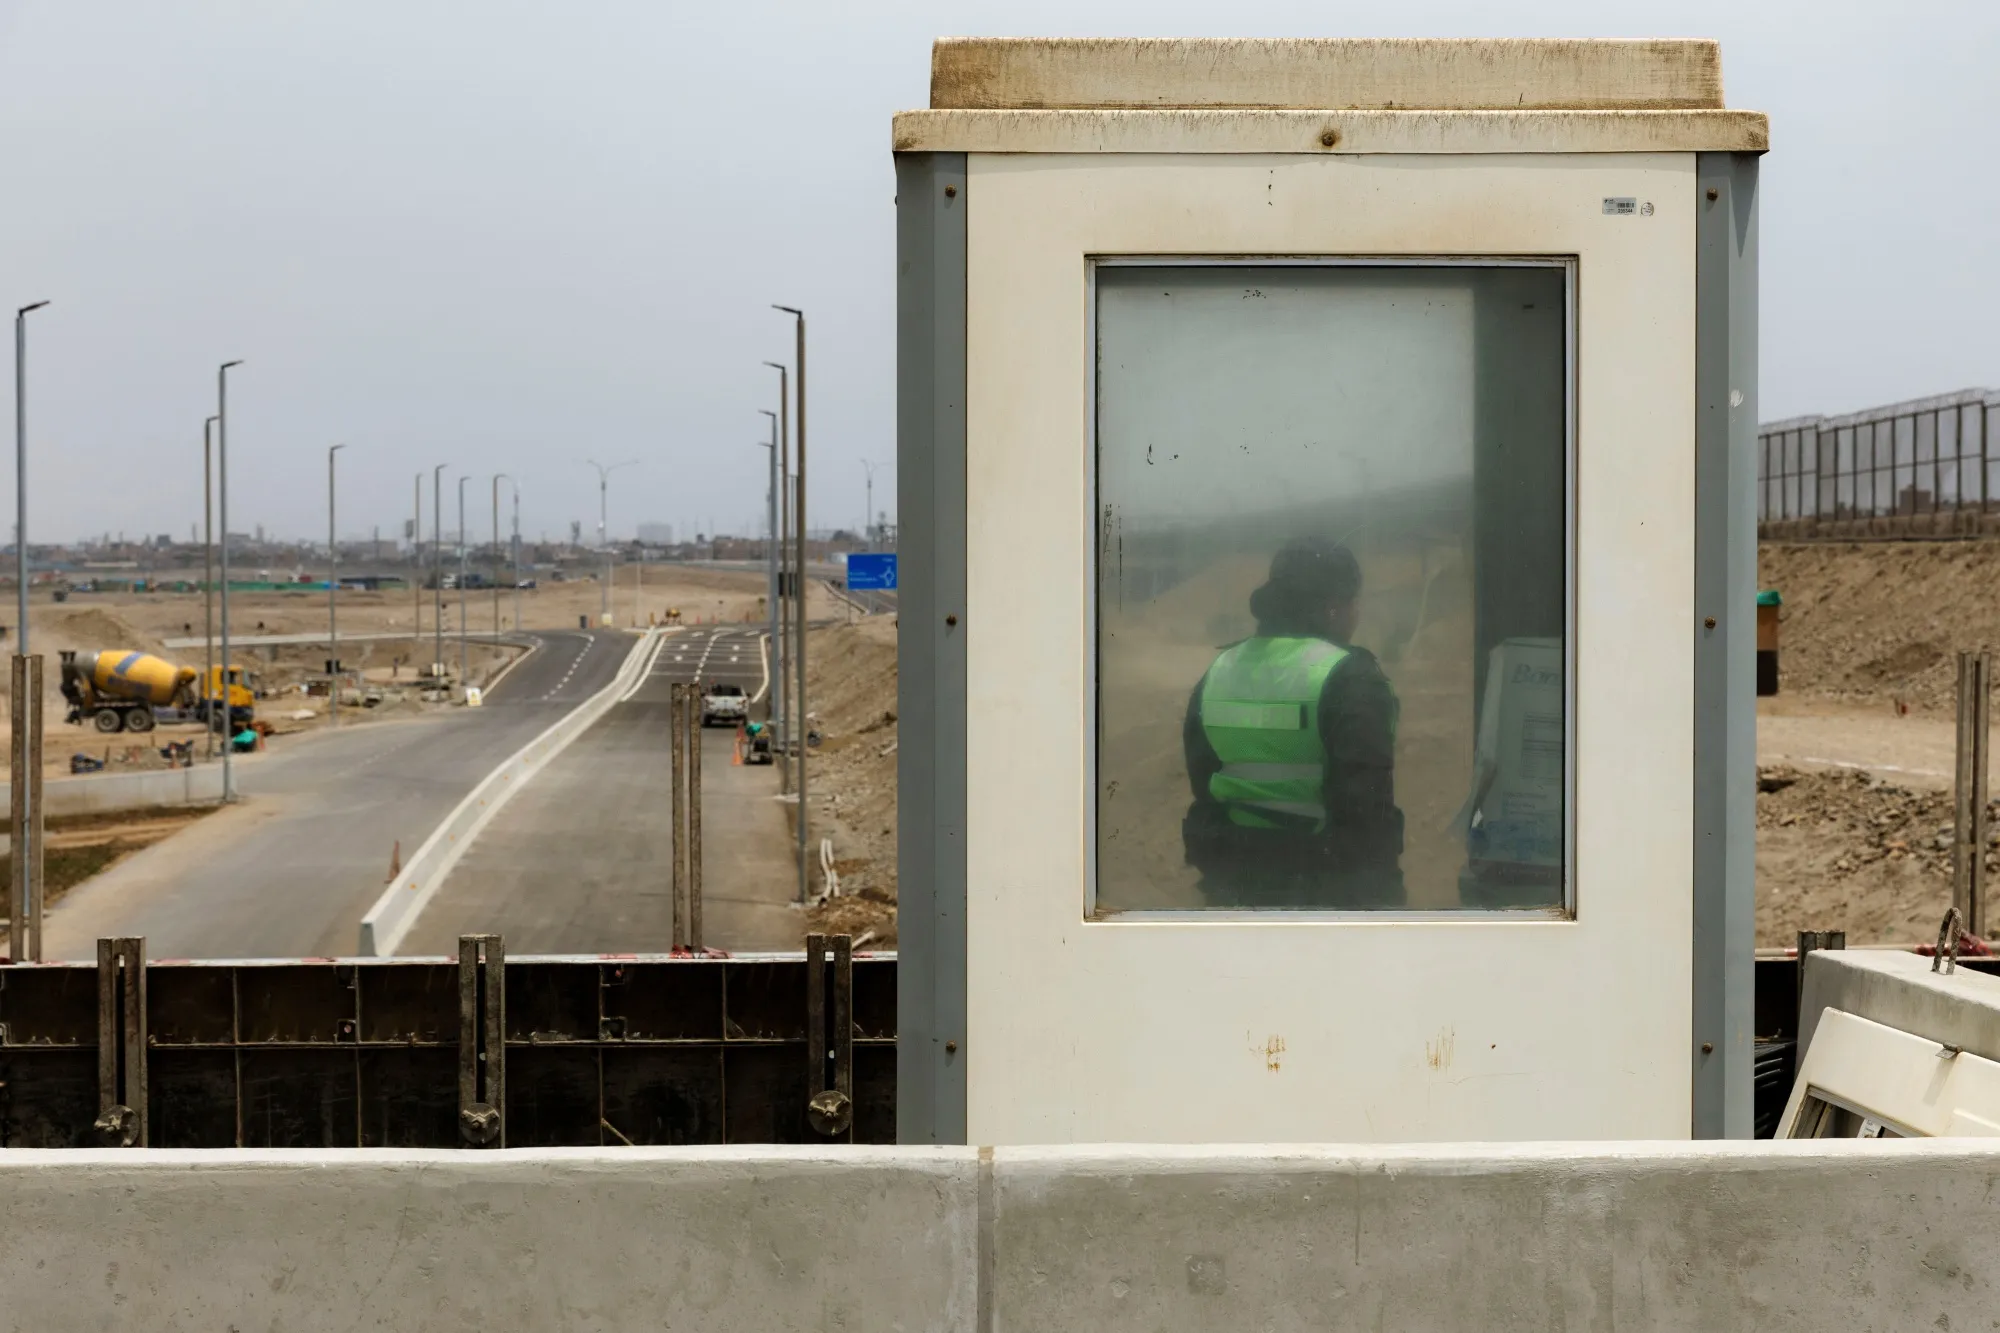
[1690, 152, 1758, 1139]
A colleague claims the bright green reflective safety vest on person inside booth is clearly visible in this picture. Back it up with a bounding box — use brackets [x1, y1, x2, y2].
[1200, 638, 1348, 833]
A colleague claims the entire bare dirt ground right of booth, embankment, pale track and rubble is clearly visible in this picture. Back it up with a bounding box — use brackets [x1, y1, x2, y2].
[1756, 542, 2000, 947]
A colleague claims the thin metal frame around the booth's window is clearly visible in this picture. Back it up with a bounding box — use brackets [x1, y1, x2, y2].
[1082, 254, 1580, 927]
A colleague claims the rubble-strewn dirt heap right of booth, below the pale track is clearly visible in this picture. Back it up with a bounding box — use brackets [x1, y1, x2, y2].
[1756, 767, 2000, 947]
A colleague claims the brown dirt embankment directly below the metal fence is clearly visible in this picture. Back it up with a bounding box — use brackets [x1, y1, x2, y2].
[1758, 542, 2000, 713]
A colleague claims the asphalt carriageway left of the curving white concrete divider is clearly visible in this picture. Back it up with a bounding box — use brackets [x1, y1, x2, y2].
[46, 630, 634, 959]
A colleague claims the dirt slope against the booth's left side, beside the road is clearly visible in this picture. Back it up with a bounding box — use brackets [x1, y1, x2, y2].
[806, 616, 896, 949]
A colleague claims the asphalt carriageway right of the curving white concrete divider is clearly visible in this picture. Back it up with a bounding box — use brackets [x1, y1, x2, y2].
[402, 626, 804, 955]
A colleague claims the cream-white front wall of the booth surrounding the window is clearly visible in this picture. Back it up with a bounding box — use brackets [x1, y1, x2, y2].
[964, 152, 1696, 1143]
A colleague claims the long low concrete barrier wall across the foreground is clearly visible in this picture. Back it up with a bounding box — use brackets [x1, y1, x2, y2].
[0, 1139, 2000, 1333]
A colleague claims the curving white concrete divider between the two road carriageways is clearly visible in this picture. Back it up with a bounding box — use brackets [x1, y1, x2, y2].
[360, 630, 658, 959]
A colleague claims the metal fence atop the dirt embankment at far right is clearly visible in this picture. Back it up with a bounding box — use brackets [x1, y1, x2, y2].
[1758, 388, 2000, 538]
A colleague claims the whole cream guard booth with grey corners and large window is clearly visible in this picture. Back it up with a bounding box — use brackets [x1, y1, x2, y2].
[894, 40, 1766, 1145]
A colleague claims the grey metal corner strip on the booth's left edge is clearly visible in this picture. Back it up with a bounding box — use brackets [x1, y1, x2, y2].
[896, 152, 966, 1143]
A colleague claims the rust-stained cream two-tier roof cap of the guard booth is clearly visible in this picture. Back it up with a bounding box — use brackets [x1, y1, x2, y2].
[894, 38, 1768, 152]
